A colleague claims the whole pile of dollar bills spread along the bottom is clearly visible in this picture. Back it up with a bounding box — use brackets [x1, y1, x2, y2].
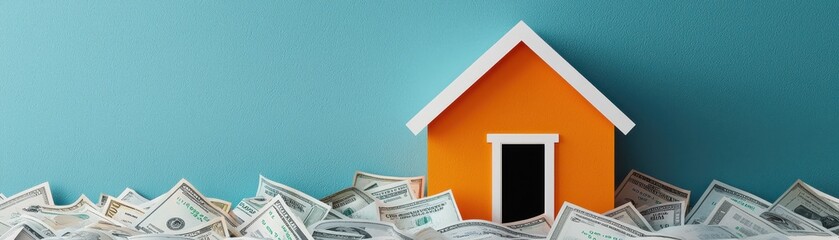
[0, 170, 839, 240]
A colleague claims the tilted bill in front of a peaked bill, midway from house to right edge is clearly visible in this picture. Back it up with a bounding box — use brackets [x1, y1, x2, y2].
[704, 197, 785, 238]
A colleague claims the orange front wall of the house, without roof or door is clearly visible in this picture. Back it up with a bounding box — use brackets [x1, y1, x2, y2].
[428, 43, 615, 220]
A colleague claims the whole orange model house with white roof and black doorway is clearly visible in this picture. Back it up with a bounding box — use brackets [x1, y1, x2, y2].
[407, 22, 635, 223]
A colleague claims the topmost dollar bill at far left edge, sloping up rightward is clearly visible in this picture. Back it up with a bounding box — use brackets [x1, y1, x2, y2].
[0, 182, 55, 222]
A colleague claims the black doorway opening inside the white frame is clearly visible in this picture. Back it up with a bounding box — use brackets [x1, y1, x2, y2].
[501, 144, 545, 223]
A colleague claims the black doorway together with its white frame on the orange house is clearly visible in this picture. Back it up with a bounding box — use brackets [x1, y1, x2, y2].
[487, 134, 559, 223]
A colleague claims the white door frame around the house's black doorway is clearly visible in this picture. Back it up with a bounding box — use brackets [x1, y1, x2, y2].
[487, 133, 559, 223]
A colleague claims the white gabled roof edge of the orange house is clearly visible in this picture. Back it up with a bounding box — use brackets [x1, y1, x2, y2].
[405, 21, 635, 135]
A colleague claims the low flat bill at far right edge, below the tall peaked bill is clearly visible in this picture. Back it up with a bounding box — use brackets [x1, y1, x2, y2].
[760, 205, 836, 236]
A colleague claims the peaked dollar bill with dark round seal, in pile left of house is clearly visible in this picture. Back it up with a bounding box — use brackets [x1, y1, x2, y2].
[135, 179, 238, 233]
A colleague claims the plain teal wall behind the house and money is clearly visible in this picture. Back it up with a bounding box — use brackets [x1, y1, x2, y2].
[0, 1, 839, 206]
